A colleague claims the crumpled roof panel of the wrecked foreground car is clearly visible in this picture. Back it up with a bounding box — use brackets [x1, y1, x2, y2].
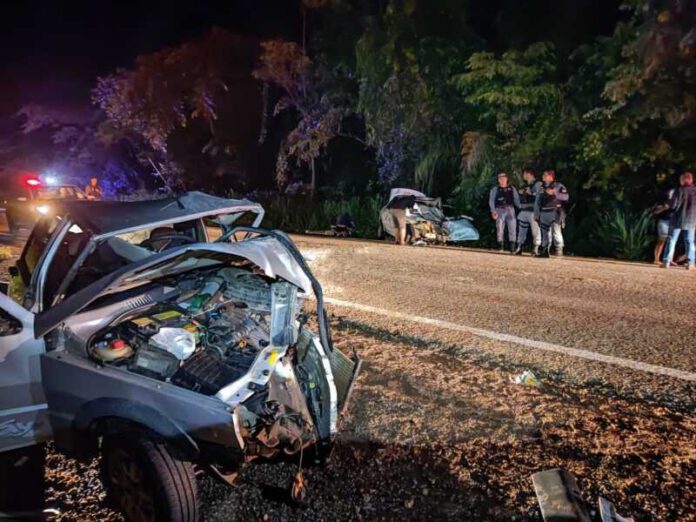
[55, 192, 263, 234]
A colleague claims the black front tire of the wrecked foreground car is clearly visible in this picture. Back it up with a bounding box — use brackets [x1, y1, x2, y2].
[101, 434, 199, 522]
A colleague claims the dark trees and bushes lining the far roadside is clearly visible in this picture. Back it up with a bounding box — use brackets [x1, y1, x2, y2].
[6, 0, 696, 259]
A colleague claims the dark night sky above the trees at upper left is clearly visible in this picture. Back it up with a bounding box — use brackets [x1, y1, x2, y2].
[0, 0, 300, 115]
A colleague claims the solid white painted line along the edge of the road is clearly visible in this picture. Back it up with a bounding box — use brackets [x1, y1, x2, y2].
[324, 297, 696, 382]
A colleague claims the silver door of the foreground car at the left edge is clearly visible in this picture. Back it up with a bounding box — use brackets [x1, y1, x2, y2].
[0, 293, 51, 452]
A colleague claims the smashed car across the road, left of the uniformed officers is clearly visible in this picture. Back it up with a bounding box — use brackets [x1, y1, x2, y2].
[378, 188, 479, 244]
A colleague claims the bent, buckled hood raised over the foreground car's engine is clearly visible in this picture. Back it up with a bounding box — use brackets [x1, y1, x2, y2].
[34, 237, 312, 337]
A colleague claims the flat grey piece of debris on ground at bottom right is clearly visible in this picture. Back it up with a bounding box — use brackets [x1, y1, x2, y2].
[532, 469, 591, 522]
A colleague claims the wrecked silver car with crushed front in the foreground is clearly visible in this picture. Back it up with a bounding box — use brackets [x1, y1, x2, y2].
[0, 193, 360, 520]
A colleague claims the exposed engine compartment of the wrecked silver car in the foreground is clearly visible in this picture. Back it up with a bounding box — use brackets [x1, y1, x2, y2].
[88, 266, 288, 395]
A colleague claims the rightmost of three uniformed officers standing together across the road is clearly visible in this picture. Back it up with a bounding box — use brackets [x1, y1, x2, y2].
[534, 170, 569, 257]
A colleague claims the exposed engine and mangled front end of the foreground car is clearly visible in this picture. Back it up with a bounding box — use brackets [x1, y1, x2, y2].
[88, 260, 348, 458]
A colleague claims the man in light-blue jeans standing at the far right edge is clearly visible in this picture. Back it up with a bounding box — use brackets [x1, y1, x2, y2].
[662, 172, 696, 270]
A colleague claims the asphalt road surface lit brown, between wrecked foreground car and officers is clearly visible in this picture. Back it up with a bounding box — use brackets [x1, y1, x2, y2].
[294, 236, 696, 405]
